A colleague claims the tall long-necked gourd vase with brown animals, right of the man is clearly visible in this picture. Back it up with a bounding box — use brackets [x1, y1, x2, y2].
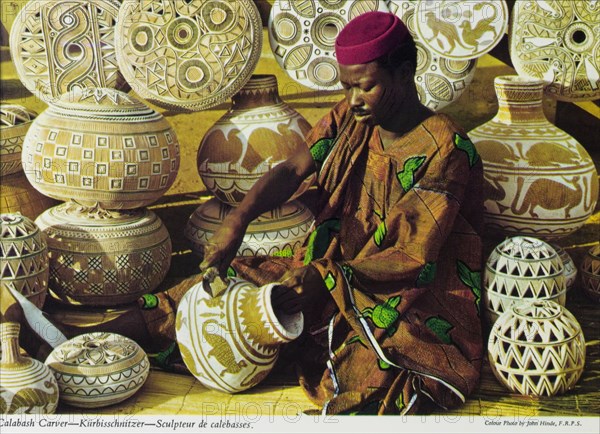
[469, 75, 598, 240]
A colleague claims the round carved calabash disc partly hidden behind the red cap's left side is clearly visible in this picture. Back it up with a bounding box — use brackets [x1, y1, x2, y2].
[268, 0, 388, 90]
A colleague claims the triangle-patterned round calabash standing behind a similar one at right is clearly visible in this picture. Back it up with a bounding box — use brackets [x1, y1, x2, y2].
[483, 236, 567, 323]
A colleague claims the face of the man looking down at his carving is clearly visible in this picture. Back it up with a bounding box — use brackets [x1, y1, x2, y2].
[340, 62, 404, 127]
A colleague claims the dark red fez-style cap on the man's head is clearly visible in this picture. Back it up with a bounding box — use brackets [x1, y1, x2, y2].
[335, 11, 409, 65]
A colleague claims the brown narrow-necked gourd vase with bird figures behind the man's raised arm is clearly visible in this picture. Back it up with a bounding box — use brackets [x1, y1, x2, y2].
[197, 75, 311, 205]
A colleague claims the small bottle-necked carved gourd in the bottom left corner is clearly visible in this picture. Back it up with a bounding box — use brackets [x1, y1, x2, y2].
[0, 322, 59, 414]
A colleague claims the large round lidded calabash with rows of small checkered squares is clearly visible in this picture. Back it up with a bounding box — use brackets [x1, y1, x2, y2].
[22, 88, 179, 209]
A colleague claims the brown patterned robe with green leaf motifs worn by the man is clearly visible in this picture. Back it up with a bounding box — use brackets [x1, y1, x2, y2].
[139, 101, 483, 414]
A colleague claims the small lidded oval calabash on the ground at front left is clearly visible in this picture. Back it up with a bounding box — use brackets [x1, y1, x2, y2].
[46, 333, 150, 408]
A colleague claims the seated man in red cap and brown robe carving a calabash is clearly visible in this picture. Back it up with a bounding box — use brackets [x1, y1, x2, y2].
[138, 12, 483, 414]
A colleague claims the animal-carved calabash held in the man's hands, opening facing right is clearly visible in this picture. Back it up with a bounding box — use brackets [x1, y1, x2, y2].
[175, 278, 304, 393]
